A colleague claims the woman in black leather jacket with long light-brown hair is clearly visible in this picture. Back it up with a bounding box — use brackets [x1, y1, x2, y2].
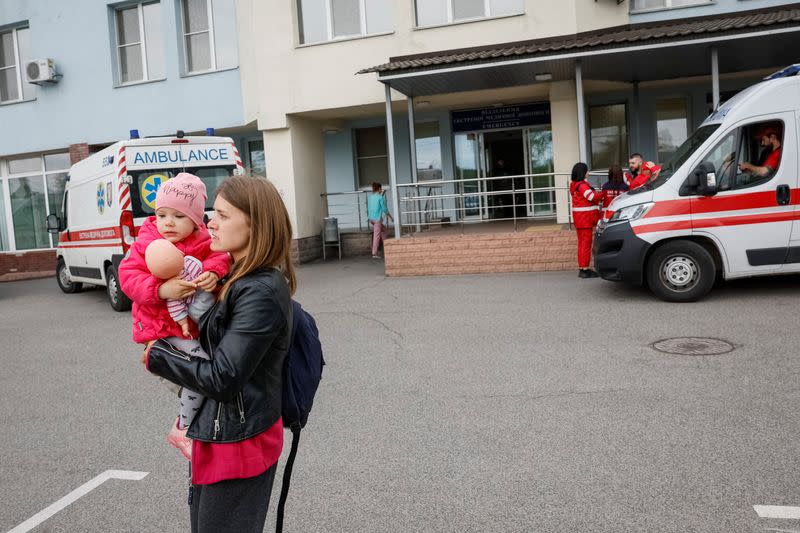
[142, 177, 296, 533]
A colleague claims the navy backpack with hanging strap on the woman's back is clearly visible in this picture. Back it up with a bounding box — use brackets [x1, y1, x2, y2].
[275, 300, 325, 533]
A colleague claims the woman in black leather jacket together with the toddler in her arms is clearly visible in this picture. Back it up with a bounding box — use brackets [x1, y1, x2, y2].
[120, 173, 296, 532]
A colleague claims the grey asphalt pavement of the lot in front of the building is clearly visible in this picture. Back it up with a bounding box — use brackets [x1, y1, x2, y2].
[0, 259, 800, 533]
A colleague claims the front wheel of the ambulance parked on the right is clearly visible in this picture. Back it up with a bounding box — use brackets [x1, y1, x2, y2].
[647, 241, 717, 302]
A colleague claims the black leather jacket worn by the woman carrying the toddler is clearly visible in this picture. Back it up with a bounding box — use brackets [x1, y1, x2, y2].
[147, 268, 292, 443]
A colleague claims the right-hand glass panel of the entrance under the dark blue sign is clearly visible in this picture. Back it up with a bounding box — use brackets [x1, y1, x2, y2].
[525, 126, 556, 217]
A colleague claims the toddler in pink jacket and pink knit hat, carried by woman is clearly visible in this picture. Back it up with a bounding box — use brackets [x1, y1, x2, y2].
[119, 172, 230, 429]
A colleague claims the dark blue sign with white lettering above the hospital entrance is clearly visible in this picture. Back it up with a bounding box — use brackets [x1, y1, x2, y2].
[451, 102, 550, 133]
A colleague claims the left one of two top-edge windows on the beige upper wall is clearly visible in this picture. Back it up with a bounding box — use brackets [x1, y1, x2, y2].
[297, 0, 392, 44]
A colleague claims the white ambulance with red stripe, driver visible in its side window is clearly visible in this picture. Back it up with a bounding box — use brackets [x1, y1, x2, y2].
[594, 65, 800, 302]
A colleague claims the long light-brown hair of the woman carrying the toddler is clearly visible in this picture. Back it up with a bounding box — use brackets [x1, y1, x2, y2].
[217, 177, 297, 299]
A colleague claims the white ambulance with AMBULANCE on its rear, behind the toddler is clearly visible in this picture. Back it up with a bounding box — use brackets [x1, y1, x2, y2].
[47, 130, 243, 311]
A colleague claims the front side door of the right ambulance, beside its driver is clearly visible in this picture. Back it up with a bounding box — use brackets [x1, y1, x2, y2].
[690, 112, 798, 277]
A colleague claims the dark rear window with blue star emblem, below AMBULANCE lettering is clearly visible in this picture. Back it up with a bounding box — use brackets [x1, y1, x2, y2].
[129, 165, 235, 218]
